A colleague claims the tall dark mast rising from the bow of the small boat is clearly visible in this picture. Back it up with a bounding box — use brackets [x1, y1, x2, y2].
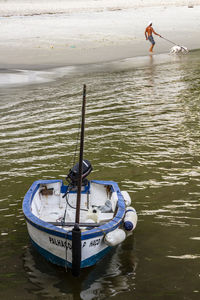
[72, 84, 86, 277]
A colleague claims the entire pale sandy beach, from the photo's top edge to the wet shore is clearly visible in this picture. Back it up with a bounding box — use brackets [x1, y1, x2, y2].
[0, 0, 200, 69]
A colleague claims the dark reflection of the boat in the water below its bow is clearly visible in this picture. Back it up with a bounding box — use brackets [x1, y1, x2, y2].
[24, 236, 138, 300]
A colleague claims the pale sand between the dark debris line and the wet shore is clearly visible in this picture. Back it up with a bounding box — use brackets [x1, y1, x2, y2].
[0, 5, 200, 72]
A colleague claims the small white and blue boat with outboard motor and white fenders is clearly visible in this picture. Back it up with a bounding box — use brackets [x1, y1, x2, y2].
[23, 85, 137, 276]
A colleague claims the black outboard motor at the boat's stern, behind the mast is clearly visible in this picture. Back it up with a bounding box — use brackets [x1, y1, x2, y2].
[66, 159, 92, 186]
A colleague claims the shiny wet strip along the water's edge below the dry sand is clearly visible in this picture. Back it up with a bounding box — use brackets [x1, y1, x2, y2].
[0, 50, 199, 88]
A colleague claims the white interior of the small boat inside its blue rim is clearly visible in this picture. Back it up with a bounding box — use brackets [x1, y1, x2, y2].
[32, 183, 117, 229]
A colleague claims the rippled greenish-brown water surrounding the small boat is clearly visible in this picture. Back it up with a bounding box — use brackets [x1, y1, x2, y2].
[0, 51, 200, 300]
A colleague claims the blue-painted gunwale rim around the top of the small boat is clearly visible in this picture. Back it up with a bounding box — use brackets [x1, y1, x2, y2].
[23, 179, 125, 240]
